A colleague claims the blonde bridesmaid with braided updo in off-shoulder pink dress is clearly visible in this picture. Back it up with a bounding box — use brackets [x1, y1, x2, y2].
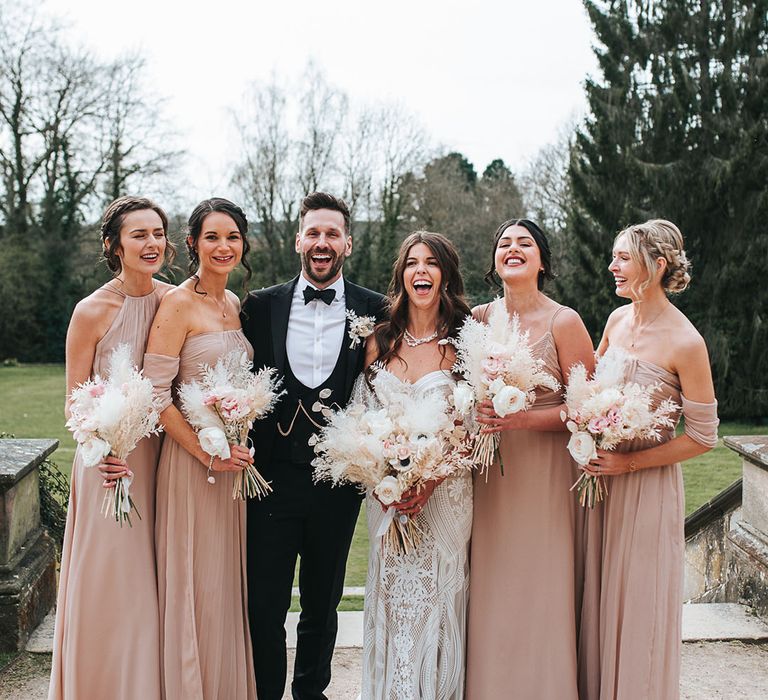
[580, 219, 718, 700]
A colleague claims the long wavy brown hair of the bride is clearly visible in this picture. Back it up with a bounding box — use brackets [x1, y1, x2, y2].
[366, 231, 471, 379]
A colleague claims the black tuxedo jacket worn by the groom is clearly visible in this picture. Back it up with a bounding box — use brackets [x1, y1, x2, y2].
[240, 275, 386, 464]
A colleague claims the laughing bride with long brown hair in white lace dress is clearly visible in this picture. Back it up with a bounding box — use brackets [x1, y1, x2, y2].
[359, 231, 472, 700]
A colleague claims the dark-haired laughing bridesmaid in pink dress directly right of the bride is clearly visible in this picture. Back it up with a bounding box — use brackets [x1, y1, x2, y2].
[466, 219, 594, 700]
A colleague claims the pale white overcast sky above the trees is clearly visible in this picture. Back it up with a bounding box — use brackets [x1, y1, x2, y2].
[45, 0, 596, 204]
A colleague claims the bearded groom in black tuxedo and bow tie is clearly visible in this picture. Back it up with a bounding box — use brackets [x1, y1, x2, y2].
[241, 192, 385, 700]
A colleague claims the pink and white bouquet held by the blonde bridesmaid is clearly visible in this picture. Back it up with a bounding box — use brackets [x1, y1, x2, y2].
[560, 348, 680, 508]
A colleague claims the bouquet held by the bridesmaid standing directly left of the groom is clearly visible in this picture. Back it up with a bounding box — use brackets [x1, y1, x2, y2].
[178, 350, 281, 500]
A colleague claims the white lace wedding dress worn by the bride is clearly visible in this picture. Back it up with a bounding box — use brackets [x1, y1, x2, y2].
[356, 370, 472, 700]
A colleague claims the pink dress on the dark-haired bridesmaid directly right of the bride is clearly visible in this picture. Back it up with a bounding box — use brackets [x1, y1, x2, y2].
[466, 302, 578, 700]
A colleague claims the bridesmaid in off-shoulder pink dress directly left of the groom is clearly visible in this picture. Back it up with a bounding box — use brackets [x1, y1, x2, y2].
[144, 198, 256, 700]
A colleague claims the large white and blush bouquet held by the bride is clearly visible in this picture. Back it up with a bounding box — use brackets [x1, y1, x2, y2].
[310, 371, 474, 553]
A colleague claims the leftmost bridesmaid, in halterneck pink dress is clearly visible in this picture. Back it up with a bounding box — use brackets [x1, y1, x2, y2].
[48, 197, 173, 700]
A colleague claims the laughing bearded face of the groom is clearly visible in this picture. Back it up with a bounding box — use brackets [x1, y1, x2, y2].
[296, 209, 352, 289]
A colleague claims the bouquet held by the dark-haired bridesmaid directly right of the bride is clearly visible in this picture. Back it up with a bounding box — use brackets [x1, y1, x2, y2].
[453, 303, 560, 474]
